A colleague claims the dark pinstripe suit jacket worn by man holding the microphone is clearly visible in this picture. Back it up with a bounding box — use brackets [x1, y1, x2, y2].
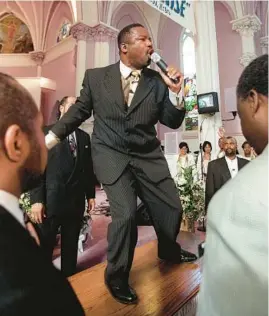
[51, 63, 185, 184]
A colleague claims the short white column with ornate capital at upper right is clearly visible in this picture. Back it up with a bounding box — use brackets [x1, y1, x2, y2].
[231, 15, 261, 67]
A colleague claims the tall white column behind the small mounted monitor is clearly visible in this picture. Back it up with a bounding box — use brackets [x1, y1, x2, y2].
[195, 1, 222, 153]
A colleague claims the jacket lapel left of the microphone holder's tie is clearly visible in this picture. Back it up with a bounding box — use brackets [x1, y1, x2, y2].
[104, 62, 124, 111]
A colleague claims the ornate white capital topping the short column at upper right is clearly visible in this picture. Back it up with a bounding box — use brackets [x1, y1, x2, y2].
[231, 15, 261, 36]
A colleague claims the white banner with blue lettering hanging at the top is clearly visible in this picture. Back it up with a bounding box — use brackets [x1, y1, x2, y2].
[144, 0, 196, 34]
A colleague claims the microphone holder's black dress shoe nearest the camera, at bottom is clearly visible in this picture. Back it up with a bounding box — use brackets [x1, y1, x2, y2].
[105, 280, 138, 304]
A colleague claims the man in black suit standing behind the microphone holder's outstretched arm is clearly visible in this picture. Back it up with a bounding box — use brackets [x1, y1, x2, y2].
[30, 96, 95, 277]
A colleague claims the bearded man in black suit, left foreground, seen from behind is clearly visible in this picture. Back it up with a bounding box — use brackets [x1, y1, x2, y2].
[0, 73, 84, 316]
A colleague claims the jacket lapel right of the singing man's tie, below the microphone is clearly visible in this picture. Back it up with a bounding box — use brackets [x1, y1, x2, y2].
[128, 68, 154, 114]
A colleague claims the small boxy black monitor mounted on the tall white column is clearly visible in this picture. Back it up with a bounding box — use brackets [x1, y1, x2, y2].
[197, 92, 219, 114]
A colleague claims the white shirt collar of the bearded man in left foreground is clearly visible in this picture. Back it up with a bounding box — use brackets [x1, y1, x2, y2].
[0, 190, 25, 227]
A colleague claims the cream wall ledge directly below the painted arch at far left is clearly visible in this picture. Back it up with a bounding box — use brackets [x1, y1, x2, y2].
[0, 54, 36, 68]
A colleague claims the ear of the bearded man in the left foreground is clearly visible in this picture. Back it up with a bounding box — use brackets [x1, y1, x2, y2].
[4, 124, 30, 163]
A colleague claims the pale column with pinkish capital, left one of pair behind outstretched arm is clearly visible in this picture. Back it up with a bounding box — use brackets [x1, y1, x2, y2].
[71, 22, 91, 96]
